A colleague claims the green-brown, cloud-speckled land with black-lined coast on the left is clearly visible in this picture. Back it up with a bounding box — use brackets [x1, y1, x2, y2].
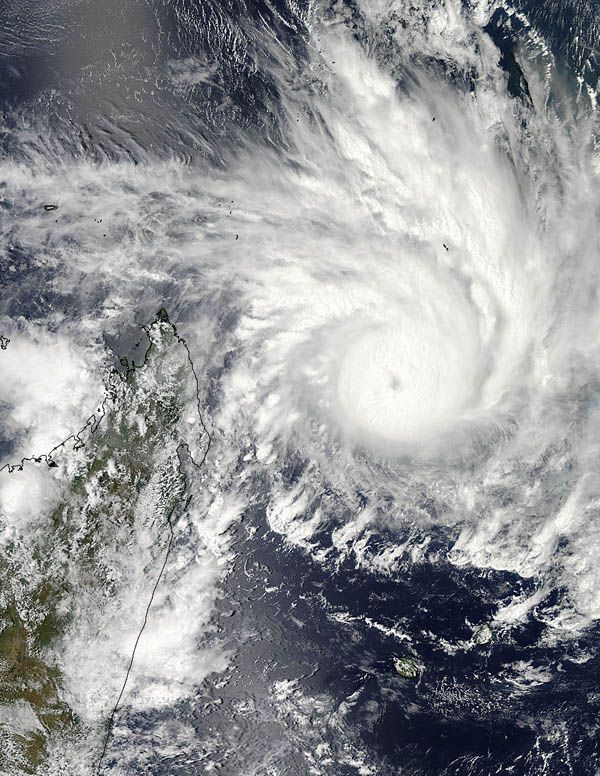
[0, 311, 208, 773]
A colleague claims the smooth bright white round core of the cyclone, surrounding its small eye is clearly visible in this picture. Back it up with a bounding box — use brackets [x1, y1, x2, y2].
[337, 314, 478, 452]
